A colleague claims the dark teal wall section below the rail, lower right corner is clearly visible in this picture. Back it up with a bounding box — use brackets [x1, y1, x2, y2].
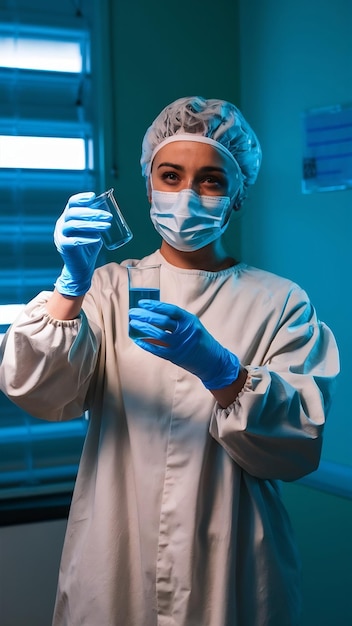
[283, 484, 352, 626]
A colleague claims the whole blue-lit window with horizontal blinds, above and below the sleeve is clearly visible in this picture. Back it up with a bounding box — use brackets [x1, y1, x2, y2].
[0, 0, 96, 516]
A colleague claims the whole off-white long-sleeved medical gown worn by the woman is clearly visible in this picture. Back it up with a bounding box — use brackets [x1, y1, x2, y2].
[1, 251, 338, 626]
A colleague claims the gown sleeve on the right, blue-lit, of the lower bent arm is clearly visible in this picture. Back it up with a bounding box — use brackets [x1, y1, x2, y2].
[210, 288, 339, 481]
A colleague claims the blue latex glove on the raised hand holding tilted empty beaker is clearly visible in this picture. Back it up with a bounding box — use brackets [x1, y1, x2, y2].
[54, 192, 112, 296]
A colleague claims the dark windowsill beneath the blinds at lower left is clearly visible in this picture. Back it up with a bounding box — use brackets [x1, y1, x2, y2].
[0, 493, 72, 526]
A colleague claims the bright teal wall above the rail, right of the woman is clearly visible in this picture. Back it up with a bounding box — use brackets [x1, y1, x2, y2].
[240, 0, 352, 465]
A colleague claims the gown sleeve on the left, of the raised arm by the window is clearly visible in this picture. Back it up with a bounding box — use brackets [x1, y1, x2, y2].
[0, 292, 101, 421]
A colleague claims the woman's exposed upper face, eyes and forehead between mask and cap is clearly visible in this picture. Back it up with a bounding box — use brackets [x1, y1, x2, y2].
[148, 141, 238, 200]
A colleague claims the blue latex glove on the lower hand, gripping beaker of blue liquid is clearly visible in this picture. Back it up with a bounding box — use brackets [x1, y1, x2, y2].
[129, 300, 240, 389]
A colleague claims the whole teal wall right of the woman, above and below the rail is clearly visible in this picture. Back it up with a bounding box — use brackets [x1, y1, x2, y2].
[240, 0, 352, 626]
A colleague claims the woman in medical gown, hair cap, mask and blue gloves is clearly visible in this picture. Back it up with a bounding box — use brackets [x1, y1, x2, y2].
[1, 98, 338, 626]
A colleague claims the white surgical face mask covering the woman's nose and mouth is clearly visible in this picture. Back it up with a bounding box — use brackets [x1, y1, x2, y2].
[150, 189, 231, 252]
